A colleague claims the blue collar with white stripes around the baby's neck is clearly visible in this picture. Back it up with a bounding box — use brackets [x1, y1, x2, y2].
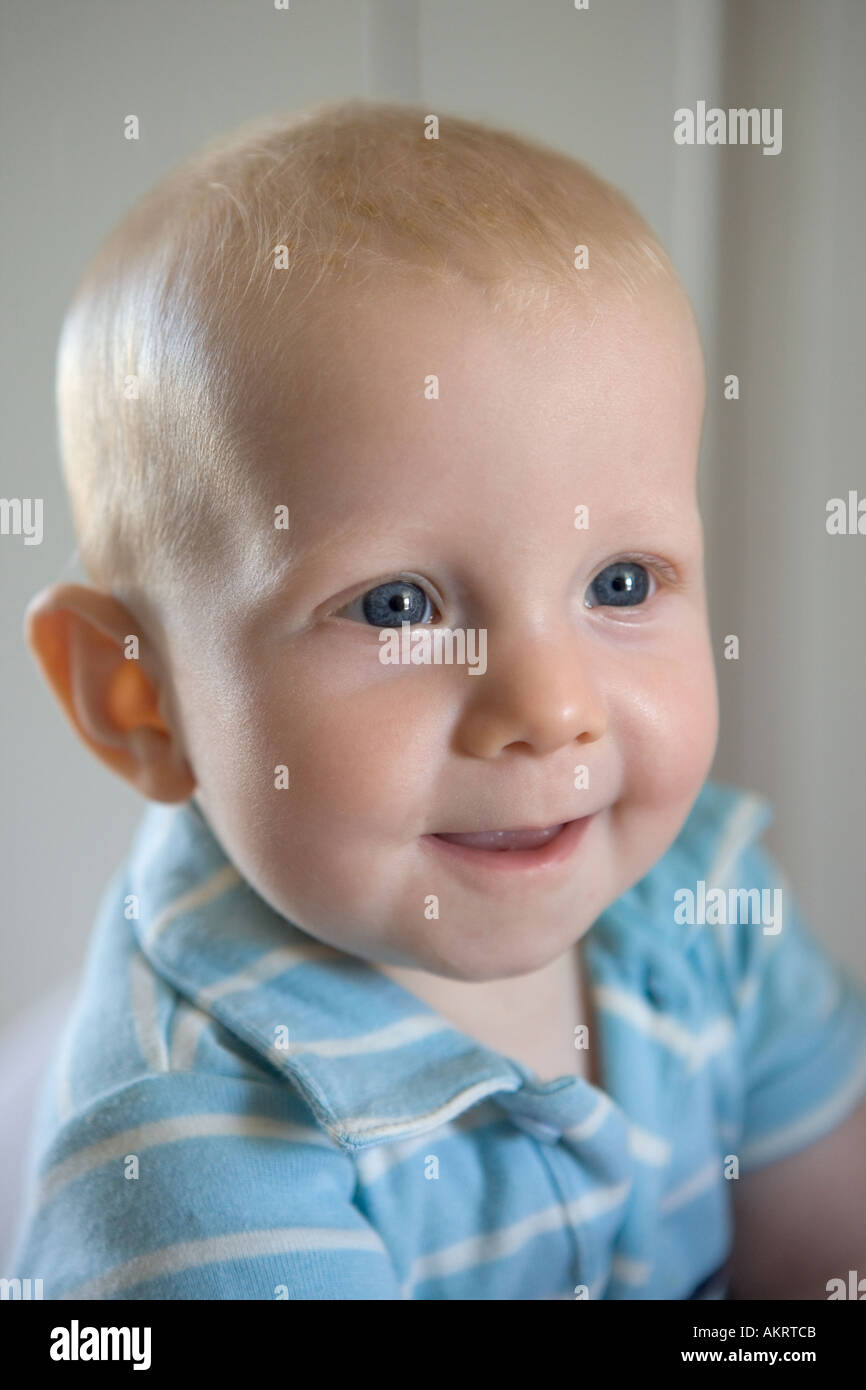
[126, 784, 771, 1150]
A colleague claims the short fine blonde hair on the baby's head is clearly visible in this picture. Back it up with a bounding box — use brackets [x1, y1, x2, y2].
[57, 100, 678, 619]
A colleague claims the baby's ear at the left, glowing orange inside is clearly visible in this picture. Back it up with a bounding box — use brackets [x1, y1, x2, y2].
[25, 584, 196, 802]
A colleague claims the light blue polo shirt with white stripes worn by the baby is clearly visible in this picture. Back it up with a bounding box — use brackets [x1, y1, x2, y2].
[11, 781, 866, 1300]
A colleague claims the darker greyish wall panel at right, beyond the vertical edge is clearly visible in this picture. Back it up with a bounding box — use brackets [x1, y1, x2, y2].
[706, 0, 866, 979]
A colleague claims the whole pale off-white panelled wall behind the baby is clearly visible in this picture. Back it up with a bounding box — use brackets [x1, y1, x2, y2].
[0, 0, 866, 1045]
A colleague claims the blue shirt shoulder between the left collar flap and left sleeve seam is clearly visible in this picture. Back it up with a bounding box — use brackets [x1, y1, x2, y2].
[22, 867, 332, 1169]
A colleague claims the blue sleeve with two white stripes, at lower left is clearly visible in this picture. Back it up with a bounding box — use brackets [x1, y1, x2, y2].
[13, 1073, 400, 1301]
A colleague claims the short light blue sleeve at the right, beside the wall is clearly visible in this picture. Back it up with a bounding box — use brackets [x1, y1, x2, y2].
[717, 844, 866, 1170]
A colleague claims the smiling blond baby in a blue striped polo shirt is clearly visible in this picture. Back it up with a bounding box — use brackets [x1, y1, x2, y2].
[8, 101, 866, 1300]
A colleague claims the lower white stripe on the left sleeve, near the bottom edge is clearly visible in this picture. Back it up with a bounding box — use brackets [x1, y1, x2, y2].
[63, 1226, 385, 1300]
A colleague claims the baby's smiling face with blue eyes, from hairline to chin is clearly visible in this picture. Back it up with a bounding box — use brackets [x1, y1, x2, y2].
[170, 276, 717, 980]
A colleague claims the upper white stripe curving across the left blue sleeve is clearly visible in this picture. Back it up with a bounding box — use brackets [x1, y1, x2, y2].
[39, 1112, 332, 1205]
